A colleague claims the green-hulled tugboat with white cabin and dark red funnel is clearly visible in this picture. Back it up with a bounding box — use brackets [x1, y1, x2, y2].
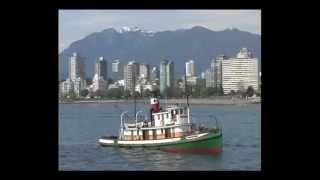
[98, 73, 223, 154]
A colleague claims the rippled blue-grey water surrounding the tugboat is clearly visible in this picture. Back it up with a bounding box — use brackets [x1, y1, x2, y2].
[58, 103, 261, 171]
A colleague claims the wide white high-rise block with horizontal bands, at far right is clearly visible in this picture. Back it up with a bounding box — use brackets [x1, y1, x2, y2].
[222, 48, 259, 94]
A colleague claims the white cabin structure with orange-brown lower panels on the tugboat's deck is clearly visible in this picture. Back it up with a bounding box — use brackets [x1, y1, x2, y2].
[119, 102, 192, 141]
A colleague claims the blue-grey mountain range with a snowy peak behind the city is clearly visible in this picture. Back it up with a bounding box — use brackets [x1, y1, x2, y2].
[59, 26, 261, 80]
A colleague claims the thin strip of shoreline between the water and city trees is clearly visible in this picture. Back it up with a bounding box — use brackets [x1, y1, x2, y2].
[59, 98, 261, 105]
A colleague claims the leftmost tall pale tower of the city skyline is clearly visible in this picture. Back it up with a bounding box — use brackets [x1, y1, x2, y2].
[69, 53, 85, 81]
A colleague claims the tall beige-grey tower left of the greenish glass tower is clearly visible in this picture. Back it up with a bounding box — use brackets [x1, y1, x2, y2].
[125, 61, 139, 93]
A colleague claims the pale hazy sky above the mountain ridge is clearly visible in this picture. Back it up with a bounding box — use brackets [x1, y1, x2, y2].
[59, 10, 261, 52]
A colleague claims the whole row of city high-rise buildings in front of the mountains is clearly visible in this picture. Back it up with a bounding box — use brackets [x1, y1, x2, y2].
[60, 48, 261, 96]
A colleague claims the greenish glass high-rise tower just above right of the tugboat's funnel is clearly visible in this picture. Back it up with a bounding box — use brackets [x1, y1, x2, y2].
[160, 60, 174, 95]
